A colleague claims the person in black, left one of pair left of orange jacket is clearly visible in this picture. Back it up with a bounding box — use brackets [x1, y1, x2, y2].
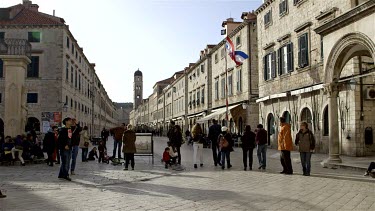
[241, 125, 255, 171]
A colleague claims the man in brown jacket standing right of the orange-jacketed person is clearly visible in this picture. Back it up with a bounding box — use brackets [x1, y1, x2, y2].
[295, 122, 315, 176]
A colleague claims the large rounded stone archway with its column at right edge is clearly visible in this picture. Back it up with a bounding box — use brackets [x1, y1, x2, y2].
[323, 31, 375, 161]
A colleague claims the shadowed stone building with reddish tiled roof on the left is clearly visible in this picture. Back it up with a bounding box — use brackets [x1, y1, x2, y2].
[0, 1, 117, 135]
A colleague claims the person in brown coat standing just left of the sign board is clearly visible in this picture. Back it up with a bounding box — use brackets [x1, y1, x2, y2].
[123, 124, 137, 170]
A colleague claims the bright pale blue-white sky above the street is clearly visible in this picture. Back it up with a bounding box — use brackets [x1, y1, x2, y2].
[0, 0, 262, 102]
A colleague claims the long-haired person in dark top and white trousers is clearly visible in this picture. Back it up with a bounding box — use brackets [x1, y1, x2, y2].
[191, 123, 204, 168]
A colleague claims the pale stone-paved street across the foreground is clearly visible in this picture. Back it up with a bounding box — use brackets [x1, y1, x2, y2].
[0, 138, 375, 210]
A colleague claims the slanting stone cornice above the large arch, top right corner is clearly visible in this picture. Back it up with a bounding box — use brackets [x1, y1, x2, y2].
[314, 1, 375, 36]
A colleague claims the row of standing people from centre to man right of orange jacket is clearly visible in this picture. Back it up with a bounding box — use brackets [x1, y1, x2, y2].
[163, 117, 315, 176]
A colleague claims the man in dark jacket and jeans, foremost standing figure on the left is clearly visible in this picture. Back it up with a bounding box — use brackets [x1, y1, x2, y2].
[58, 117, 73, 181]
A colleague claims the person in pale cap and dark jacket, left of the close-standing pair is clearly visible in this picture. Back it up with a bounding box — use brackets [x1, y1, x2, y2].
[218, 126, 233, 170]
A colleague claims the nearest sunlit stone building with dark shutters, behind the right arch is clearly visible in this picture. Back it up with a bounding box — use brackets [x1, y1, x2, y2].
[256, 0, 375, 156]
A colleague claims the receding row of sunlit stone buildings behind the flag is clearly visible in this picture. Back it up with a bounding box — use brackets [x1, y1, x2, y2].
[131, 13, 259, 137]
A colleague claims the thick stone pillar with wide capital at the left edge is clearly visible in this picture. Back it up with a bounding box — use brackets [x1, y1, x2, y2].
[1, 55, 31, 137]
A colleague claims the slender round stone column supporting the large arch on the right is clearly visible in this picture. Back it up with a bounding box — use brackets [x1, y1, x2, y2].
[322, 82, 341, 167]
